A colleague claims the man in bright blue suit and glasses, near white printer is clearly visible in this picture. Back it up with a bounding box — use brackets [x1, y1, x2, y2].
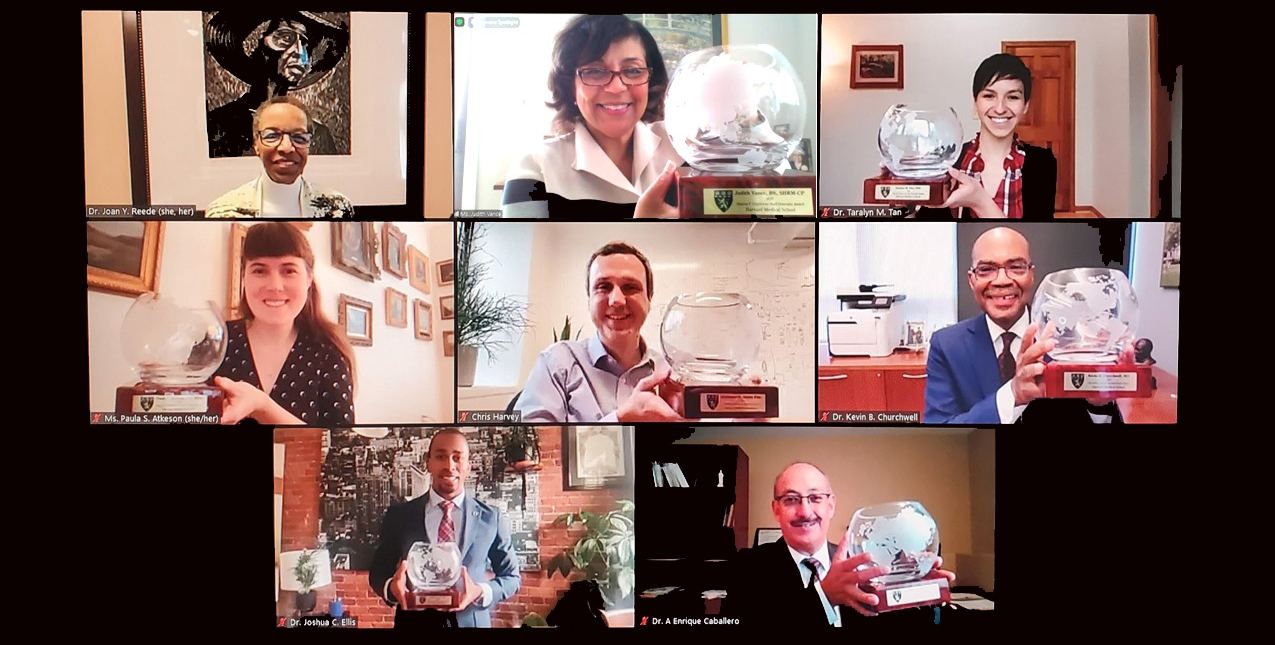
[924, 227, 1132, 423]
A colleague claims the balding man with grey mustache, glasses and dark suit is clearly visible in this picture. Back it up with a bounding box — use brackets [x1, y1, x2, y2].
[722, 461, 956, 627]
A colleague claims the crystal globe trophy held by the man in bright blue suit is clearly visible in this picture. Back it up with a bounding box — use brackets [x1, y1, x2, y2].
[1031, 269, 1151, 398]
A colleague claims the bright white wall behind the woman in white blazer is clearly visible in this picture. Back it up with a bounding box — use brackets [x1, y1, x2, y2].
[454, 14, 819, 209]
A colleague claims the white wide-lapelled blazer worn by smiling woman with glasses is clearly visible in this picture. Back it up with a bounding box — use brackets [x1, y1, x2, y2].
[504, 121, 682, 217]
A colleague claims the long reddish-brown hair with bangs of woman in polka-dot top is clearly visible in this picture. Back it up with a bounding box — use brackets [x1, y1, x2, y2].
[240, 222, 358, 389]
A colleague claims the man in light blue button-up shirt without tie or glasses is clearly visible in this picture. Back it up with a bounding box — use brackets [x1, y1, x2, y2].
[515, 242, 686, 423]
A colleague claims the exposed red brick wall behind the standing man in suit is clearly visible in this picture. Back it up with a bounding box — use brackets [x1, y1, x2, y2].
[274, 427, 621, 627]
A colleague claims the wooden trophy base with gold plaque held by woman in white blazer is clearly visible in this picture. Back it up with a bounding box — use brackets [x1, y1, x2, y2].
[674, 166, 816, 218]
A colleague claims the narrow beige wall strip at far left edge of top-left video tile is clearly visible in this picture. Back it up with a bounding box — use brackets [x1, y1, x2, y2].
[80, 11, 133, 204]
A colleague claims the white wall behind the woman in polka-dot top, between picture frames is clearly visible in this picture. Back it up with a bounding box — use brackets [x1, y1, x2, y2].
[88, 222, 455, 424]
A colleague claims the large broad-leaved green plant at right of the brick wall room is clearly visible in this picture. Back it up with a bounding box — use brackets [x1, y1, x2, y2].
[548, 500, 635, 609]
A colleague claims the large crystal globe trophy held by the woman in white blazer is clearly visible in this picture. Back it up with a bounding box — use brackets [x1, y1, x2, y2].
[664, 45, 815, 217]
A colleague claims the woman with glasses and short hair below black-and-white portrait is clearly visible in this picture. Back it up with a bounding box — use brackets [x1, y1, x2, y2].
[204, 96, 354, 218]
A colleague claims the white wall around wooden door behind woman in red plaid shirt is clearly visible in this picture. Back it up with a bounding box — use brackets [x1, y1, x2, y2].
[820, 14, 1150, 217]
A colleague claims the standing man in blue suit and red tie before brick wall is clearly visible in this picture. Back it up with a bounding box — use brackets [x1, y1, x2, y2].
[367, 428, 521, 627]
